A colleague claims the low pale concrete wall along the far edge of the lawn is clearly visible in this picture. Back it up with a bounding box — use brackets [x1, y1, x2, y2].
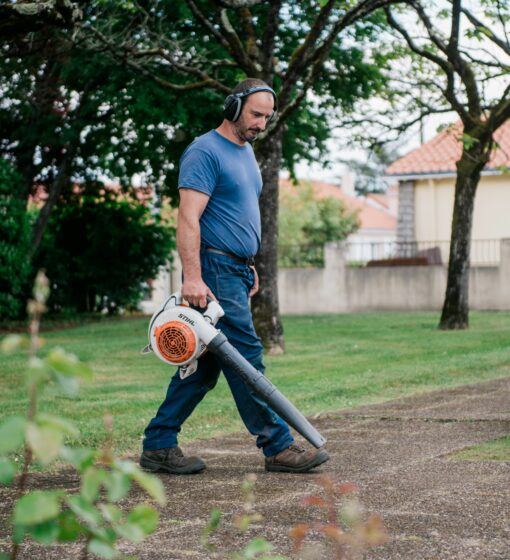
[278, 239, 510, 314]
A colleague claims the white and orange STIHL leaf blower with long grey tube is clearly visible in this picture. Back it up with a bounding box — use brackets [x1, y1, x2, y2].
[142, 292, 326, 448]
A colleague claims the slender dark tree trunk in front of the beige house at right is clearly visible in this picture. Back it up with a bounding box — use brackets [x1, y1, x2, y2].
[439, 143, 490, 330]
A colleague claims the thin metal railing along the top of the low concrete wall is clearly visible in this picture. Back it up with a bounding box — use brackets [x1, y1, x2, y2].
[279, 239, 501, 268]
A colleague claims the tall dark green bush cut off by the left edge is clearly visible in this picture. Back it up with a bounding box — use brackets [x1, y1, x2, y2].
[0, 158, 30, 319]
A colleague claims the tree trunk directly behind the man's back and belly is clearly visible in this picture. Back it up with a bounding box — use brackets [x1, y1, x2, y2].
[252, 127, 284, 354]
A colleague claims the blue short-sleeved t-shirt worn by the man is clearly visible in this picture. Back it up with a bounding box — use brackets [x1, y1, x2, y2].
[179, 130, 262, 258]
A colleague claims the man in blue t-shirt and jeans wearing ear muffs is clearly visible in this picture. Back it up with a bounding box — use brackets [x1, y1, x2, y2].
[140, 79, 329, 474]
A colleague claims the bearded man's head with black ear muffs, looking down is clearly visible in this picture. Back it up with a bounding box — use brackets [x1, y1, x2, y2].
[223, 78, 276, 142]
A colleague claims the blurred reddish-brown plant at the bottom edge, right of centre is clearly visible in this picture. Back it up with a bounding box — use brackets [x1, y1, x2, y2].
[290, 476, 387, 560]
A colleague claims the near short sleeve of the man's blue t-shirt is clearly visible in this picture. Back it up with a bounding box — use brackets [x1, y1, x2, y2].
[179, 146, 219, 196]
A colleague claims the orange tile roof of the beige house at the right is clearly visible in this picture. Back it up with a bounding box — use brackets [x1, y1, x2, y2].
[385, 121, 510, 175]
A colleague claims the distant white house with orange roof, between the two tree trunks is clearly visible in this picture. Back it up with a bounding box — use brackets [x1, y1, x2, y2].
[280, 175, 398, 262]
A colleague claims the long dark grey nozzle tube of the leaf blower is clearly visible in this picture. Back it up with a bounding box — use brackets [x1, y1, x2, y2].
[207, 332, 326, 448]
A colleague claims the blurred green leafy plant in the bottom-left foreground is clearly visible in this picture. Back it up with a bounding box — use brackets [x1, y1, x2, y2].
[0, 272, 165, 560]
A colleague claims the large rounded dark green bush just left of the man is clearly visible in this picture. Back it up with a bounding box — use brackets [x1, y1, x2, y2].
[34, 186, 175, 313]
